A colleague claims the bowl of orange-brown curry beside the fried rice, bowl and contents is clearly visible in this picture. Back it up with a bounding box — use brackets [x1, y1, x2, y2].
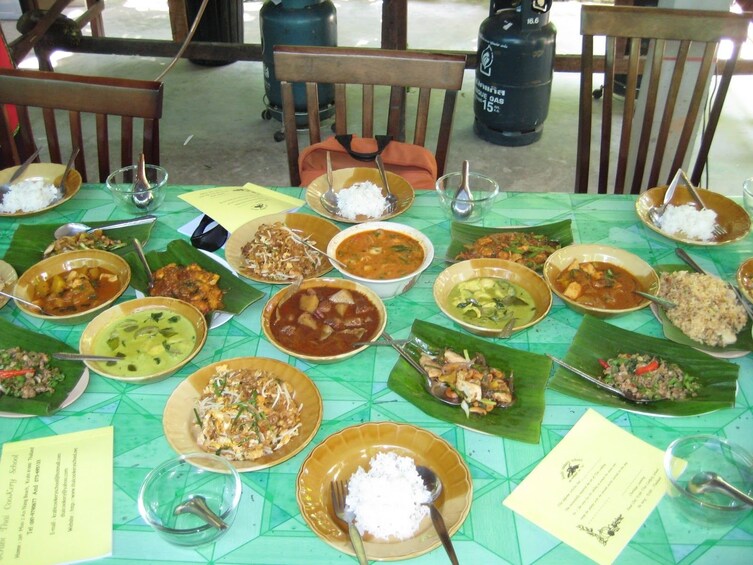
[543, 244, 659, 318]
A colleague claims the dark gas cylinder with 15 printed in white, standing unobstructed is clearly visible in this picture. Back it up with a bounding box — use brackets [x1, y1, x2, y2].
[473, 0, 557, 146]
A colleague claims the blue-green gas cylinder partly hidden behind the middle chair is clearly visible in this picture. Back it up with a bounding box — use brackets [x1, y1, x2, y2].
[259, 0, 337, 125]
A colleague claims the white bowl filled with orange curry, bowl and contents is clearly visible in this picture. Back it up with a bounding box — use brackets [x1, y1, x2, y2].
[327, 222, 434, 300]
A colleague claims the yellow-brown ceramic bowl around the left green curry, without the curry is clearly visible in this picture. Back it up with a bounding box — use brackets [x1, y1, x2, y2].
[78, 296, 207, 384]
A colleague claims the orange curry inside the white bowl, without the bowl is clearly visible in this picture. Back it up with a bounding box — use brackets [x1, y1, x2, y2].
[335, 229, 424, 280]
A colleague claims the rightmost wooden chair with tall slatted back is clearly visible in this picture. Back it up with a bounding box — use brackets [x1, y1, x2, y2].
[575, 5, 750, 194]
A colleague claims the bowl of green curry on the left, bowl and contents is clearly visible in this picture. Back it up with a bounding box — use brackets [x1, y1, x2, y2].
[78, 296, 208, 384]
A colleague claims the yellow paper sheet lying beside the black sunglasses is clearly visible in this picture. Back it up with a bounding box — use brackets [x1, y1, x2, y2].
[179, 183, 304, 233]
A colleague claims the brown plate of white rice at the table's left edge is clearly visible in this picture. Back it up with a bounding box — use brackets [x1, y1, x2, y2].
[0, 163, 81, 216]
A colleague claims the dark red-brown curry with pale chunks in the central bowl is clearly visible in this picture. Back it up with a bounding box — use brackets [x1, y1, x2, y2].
[270, 287, 380, 357]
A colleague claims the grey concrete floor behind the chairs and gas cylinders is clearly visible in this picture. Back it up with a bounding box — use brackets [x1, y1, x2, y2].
[2, 0, 753, 194]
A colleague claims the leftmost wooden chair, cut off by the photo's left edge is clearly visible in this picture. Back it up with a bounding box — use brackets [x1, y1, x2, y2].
[0, 69, 162, 182]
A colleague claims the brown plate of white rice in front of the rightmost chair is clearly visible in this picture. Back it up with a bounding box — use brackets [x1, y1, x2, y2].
[635, 186, 751, 246]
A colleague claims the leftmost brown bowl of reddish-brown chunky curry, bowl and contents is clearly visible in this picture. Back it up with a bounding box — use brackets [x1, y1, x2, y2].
[13, 249, 131, 325]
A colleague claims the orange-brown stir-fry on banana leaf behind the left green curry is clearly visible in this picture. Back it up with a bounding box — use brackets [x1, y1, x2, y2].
[149, 263, 224, 314]
